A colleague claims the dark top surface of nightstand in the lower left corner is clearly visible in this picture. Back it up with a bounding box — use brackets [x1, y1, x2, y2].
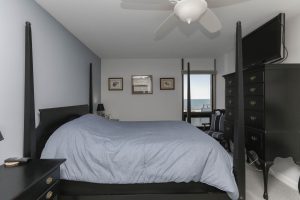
[0, 159, 65, 199]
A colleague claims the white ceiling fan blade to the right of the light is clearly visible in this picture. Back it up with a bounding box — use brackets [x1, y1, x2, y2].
[199, 9, 222, 33]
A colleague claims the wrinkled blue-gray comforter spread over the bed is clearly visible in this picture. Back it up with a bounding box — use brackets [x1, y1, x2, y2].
[41, 115, 238, 199]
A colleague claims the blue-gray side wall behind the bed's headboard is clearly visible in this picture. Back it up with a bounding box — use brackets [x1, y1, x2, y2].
[0, 0, 101, 164]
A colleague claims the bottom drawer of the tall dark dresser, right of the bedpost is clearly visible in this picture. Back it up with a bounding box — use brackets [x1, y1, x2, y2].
[246, 127, 265, 159]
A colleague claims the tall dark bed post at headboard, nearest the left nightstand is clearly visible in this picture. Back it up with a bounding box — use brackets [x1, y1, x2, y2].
[23, 22, 35, 157]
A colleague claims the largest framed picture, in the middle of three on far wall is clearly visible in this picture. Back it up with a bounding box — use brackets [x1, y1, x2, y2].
[131, 75, 153, 94]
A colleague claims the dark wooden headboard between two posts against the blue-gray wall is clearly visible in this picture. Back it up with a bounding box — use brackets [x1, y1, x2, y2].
[33, 105, 89, 159]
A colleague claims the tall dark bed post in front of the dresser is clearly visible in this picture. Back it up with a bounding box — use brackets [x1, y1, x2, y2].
[234, 22, 246, 200]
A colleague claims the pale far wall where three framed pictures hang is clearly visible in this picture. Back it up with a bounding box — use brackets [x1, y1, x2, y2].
[101, 58, 214, 121]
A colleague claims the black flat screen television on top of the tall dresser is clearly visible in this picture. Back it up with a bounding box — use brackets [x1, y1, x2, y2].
[243, 13, 285, 68]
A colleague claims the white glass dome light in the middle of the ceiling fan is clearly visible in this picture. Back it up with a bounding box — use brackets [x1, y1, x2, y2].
[174, 0, 207, 24]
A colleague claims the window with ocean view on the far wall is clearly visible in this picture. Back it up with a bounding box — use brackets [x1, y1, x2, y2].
[184, 74, 213, 127]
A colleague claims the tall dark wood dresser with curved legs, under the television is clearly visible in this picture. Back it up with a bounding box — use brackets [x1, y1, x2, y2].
[224, 64, 300, 199]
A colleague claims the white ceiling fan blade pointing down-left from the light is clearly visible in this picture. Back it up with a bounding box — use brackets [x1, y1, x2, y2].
[154, 12, 179, 40]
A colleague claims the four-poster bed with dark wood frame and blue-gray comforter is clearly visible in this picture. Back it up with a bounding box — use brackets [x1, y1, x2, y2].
[24, 23, 245, 200]
